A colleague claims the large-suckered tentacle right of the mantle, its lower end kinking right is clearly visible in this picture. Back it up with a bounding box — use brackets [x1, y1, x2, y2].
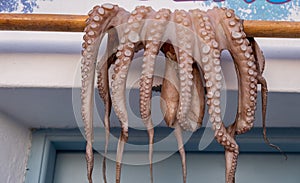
[193, 10, 239, 183]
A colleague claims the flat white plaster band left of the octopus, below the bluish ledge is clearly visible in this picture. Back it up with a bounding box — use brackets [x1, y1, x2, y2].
[0, 53, 80, 88]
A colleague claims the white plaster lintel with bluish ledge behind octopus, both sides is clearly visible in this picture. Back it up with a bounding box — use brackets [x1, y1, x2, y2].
[0, 31, 300, 92]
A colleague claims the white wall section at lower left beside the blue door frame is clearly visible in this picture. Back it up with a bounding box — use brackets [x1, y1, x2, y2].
[0, 112, 31, 183]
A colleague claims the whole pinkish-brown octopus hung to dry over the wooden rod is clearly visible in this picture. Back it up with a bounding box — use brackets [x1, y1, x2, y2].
[81, 4, 277, 183]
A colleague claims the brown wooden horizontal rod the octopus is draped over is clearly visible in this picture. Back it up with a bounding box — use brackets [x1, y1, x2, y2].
[0, 13, 300, 38]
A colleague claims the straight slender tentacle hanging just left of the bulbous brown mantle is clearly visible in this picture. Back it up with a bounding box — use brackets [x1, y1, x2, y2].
[140, 9, 171, 182]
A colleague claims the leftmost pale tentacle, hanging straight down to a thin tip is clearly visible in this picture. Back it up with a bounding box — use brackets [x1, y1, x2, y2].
[81, 4, 119, 183]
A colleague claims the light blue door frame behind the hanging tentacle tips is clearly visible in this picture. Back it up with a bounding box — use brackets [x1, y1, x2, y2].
[25, 128, 300, 183]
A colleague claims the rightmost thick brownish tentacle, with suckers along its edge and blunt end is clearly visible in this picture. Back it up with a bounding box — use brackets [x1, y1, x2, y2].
[208, 8, 259, 134]
